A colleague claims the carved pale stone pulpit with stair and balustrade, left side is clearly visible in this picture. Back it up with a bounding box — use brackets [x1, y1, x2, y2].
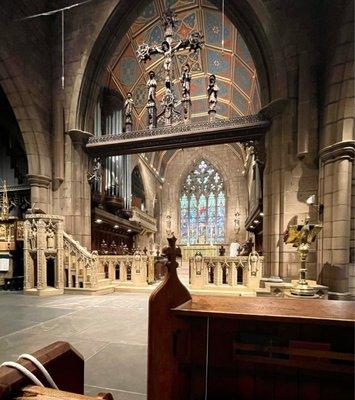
[24, 214, 154, 295]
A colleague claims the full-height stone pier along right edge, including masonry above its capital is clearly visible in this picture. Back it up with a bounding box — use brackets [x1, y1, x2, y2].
[318, 1, 355, 294]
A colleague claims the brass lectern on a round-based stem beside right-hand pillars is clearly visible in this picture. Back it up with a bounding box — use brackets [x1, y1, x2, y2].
[284, 221, 323, 296]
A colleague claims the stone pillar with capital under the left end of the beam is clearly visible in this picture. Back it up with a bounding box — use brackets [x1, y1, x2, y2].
[69, 129, 91, 249]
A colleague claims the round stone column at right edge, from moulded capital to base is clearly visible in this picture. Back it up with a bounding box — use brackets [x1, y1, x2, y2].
[317, 140, 355, 293]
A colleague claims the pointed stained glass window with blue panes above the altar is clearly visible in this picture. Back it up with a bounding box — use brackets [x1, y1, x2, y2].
[180, 160, 226, 244]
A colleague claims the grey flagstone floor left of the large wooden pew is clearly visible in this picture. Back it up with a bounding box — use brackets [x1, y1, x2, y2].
[0, 291, 149, 400]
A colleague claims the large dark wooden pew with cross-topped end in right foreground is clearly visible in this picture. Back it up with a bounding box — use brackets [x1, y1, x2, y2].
[148, 240, 355, 400]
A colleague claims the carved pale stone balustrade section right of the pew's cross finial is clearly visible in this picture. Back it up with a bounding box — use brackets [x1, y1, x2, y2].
[189, 252, 264, 295]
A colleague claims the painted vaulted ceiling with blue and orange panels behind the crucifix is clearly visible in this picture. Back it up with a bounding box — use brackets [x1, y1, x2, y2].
[102, 0, 260, 129]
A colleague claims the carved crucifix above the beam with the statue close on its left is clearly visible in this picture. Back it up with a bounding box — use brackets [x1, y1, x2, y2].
[137, 9, 202, 129]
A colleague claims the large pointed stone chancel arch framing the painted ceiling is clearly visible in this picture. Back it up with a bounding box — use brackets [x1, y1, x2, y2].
[74, 0, 287, 131]
